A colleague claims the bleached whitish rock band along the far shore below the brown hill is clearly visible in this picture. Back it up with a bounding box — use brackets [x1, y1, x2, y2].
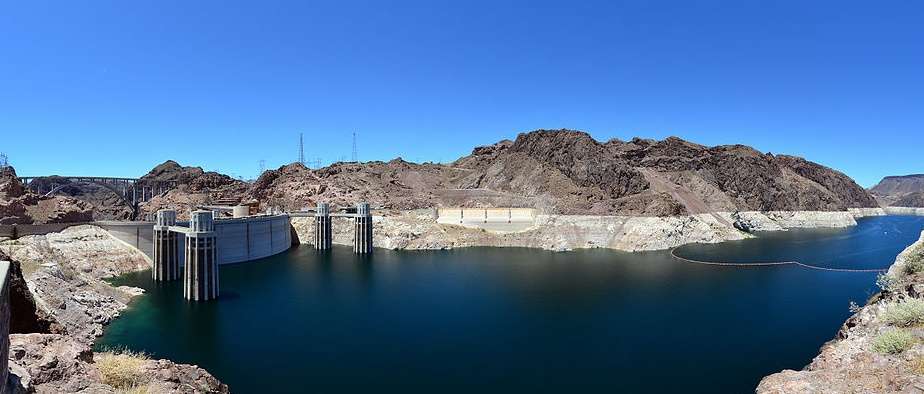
[292, 208, 924, 252]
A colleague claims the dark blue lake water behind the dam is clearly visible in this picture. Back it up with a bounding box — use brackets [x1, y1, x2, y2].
[98, 216, 924, 393]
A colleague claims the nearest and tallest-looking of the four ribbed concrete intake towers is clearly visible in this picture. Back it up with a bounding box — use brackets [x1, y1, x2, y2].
[183, 211, 218, 301]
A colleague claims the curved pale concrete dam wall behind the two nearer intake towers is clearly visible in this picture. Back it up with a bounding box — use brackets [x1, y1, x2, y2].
[98, 215, 292, 265]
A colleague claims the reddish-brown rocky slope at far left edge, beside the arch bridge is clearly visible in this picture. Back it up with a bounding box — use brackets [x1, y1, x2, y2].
[0, 166, 93, 224]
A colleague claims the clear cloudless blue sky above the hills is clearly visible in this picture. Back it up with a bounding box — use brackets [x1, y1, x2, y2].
[0, 0, 924, 186]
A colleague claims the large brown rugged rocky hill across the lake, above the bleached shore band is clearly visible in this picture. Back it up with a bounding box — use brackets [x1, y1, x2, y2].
[246, 130, 877, 216]
